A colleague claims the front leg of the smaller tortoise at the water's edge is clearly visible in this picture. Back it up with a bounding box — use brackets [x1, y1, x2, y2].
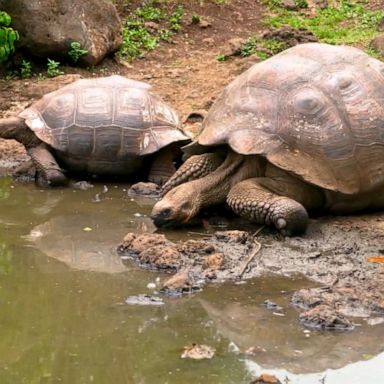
[28, 144, 68, 187]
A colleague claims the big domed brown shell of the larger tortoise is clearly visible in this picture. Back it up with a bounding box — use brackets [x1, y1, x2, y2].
[197, 43, 384, 194]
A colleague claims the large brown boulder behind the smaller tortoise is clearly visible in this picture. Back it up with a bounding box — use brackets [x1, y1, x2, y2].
[0, 0, 122, 65]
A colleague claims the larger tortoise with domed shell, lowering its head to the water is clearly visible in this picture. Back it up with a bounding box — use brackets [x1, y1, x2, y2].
[152, 43, 384, 235]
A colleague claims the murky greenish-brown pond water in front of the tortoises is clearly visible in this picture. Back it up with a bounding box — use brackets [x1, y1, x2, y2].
[0, 179, 384, 384]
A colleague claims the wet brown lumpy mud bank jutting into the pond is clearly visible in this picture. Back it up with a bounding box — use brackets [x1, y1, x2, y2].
[117, 219, 384, 331]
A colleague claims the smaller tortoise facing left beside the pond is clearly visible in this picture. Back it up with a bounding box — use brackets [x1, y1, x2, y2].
[0, 76, 189, 186]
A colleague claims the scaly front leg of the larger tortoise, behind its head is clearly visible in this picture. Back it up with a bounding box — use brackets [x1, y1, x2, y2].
[161, 153, 223, 196]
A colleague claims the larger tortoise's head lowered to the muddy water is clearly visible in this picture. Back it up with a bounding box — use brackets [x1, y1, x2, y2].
[151, 181, 201, 227]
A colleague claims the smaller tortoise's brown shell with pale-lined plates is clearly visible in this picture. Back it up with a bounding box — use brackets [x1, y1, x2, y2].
[20, 76, 189, 173]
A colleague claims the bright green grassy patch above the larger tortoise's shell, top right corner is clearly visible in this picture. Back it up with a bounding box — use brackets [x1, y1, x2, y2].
[265, 0, 384, 46]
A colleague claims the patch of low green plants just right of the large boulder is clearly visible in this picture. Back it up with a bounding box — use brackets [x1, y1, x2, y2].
[119, 0, 184, 61]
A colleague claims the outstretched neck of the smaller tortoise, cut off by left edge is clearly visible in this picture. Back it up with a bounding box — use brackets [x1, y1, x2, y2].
[0, 117, 41, 148]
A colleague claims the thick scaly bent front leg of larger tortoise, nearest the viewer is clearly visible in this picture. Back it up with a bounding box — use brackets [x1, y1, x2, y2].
[227, 167, 324, 236]
